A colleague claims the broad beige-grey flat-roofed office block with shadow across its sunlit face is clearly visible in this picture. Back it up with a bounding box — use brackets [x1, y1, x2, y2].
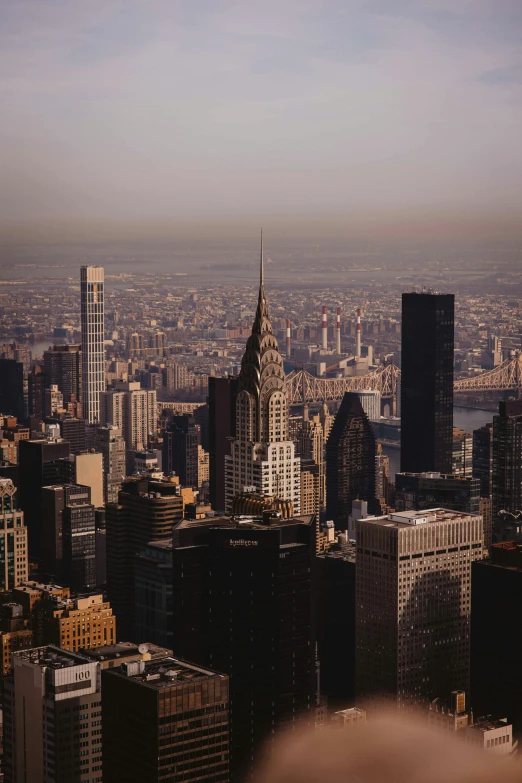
[356, 508, 484, 707]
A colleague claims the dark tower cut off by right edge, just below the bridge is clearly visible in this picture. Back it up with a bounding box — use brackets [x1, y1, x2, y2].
[491, 400, 522, 527]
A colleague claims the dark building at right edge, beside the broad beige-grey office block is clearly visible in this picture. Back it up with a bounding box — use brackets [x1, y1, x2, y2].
[471, 541, 522, 737]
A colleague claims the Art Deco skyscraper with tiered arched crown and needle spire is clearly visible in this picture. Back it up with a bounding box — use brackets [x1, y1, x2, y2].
[225, 234, 300, 514]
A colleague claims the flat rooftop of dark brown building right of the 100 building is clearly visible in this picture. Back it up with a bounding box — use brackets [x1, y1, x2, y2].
[109, 656, 227, 690]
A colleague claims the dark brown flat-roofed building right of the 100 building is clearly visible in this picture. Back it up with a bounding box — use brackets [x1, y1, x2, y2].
[102, 658, 229, 783]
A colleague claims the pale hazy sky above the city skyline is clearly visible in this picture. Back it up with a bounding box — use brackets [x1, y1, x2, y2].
[0, 0, 522, 225]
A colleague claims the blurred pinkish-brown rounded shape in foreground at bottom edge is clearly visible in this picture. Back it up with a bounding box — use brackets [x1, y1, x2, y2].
[256, 711, 522, 783]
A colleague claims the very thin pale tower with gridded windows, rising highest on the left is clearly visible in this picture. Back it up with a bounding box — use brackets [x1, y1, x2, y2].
[80, 266, 105, 424]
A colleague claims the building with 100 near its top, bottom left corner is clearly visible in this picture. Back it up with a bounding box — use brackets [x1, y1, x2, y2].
[4, 646, 102, 783]
